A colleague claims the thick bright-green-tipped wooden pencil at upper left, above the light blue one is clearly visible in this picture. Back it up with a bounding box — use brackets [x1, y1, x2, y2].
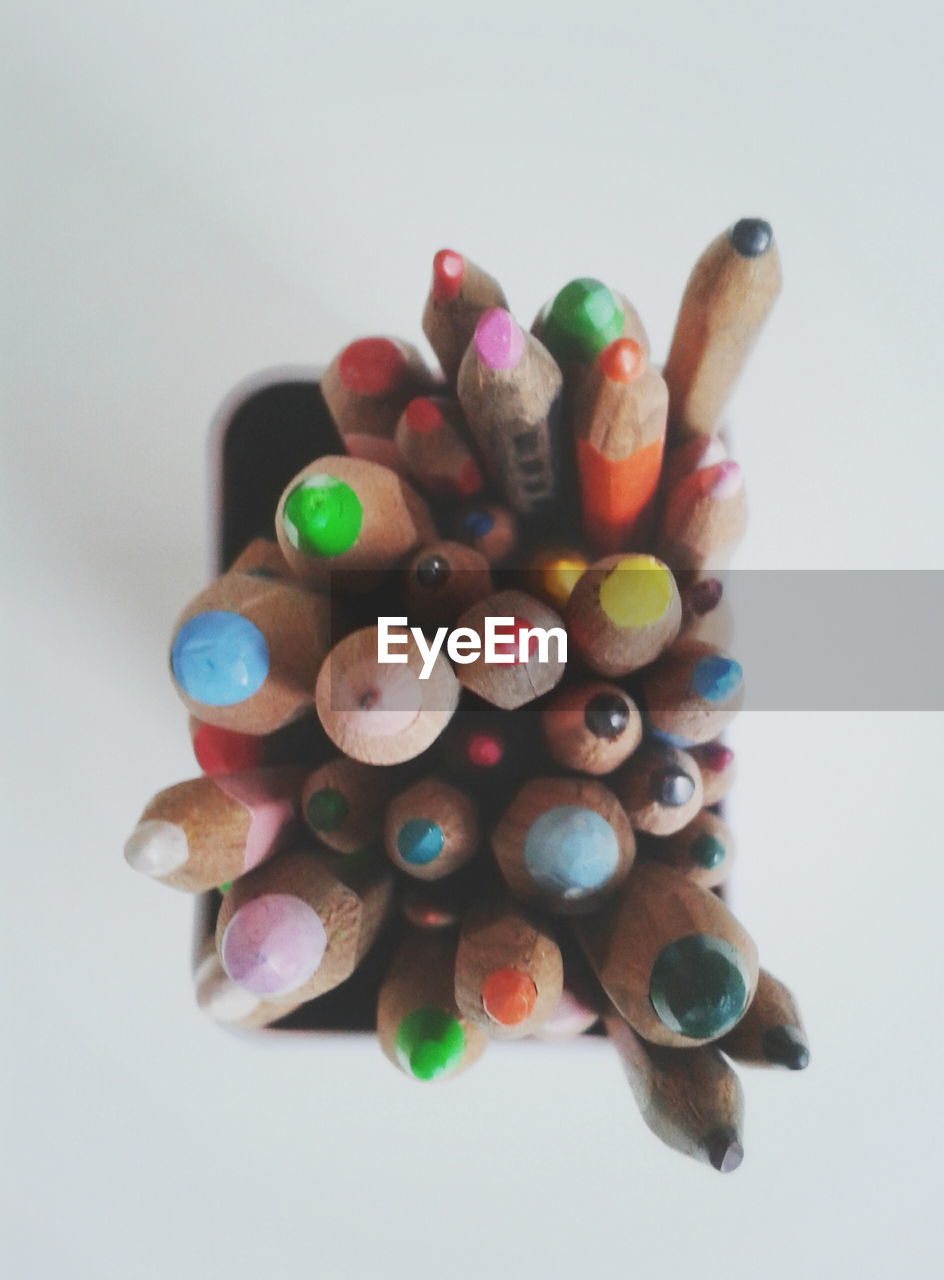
[275, 457, 436, 591]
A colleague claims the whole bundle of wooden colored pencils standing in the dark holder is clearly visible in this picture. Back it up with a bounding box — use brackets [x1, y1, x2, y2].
[125, 219, 808, 1171]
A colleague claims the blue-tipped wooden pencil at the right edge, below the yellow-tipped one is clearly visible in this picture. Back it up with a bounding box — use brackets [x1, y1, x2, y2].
[640, 639, 744, 748]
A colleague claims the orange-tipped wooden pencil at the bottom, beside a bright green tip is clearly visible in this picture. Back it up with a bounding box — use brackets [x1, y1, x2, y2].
[455, 897, 564, 1039]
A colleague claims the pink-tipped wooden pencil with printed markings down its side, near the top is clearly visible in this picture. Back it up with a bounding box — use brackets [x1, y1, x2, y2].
[457, 307, 562, 513]
